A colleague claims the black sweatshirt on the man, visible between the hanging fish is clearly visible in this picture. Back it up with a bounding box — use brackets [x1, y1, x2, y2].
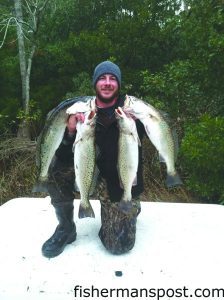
[56, 96, 145, 202]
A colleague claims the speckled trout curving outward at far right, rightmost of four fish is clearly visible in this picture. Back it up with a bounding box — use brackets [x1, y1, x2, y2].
[124, 96, 182, 187]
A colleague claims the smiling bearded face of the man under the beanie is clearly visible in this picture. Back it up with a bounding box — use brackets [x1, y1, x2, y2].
[96, 74, 119, 103]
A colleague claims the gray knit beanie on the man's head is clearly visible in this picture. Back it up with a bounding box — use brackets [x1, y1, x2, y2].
[93, 60, 121, 88]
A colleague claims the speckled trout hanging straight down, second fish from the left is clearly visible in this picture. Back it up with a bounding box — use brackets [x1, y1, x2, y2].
[73, 111, 96, 218]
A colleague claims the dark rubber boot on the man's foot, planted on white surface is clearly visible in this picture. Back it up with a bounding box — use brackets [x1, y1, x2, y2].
[42, 203, 76, 258]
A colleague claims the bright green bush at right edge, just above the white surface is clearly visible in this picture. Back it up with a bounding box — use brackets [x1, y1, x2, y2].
[180, 114, 224, 204]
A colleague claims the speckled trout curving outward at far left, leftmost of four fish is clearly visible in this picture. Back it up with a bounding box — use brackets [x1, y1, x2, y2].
[32, 97, 95, 192]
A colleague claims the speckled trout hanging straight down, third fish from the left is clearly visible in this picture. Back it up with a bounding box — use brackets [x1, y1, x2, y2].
[115, 107, 140, 212]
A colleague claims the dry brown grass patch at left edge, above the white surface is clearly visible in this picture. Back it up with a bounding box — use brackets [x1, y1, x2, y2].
[0, 137, 39, 204]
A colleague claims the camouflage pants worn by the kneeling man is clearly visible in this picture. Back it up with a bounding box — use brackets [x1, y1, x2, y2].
[48, 159, 140, 254]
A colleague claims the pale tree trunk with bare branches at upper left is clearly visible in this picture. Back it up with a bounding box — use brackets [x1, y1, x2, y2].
[0, 0, 51, 137]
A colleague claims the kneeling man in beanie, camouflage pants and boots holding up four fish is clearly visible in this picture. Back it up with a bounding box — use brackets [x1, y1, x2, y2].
[42, 61, 144, 257]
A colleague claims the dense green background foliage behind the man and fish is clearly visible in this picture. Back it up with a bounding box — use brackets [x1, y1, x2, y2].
[0, 0, 224, 203]
